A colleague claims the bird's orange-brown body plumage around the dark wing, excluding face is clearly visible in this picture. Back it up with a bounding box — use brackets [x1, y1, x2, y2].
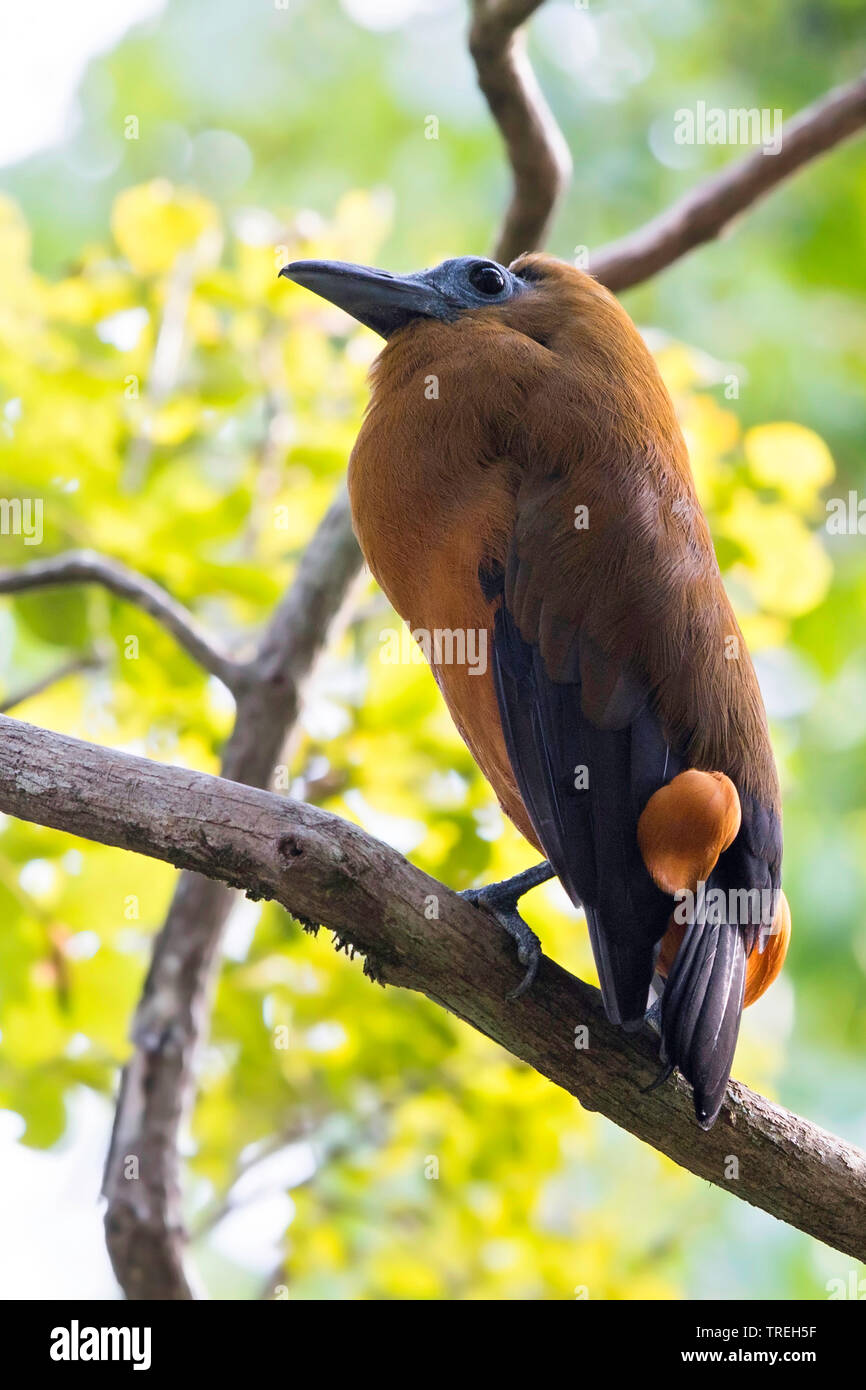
[349, 254, 778, 806]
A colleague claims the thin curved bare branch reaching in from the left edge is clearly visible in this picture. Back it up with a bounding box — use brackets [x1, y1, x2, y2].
[0, 550, 239, 689]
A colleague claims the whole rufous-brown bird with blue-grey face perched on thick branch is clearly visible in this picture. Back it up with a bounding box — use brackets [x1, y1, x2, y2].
[279, 252, 791, 1129]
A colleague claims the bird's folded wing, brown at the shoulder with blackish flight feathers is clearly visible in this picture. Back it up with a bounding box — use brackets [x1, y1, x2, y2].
[485, 477, 683, 1023]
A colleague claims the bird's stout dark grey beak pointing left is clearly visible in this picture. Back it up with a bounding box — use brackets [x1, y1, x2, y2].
[279, 261, 456, 338]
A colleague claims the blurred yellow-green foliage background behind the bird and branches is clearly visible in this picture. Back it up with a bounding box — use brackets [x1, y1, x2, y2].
[0, 0, 866, 1300]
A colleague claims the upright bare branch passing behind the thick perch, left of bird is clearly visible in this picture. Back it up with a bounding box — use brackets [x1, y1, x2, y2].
[104, 488, 361, 1300]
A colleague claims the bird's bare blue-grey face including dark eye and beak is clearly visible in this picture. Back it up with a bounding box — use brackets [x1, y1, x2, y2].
[279, 256, 530, 338]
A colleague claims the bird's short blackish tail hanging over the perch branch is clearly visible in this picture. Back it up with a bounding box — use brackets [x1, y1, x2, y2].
[662, 874, 748, 1129]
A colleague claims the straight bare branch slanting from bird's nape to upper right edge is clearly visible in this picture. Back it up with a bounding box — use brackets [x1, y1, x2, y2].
[589, 75, 866, 291]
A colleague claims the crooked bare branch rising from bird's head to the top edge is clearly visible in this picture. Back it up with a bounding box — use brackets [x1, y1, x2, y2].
[468, 0, 571, 265]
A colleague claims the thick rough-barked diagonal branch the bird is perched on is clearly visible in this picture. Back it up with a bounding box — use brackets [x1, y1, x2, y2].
[0, 717, 866, 1259]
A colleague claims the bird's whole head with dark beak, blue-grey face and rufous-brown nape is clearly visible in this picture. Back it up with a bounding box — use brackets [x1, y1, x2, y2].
[279, 253, 684, 455]
